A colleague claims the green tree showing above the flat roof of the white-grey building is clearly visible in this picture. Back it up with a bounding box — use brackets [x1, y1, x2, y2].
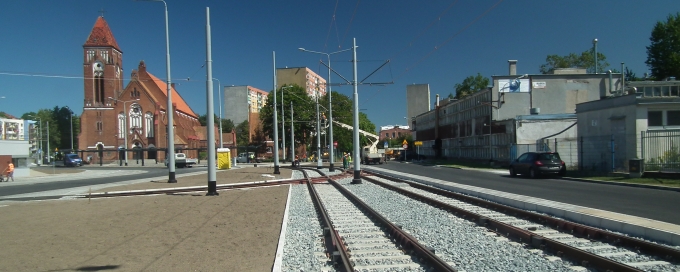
[540, 49, 609, 74]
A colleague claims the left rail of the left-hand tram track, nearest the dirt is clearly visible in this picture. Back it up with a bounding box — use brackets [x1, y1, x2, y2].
[302, 169, 354, 272]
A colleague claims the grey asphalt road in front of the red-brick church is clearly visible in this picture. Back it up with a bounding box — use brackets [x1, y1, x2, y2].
[0, 167, 207, 200]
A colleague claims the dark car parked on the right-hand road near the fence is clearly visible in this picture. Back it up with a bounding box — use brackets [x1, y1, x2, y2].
[510, 152, 567, 178]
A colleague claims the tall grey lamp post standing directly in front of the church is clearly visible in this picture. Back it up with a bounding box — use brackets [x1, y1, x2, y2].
[135, 0, 177, 183]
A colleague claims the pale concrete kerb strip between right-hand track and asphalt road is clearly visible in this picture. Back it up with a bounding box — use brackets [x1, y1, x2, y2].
[366, 167, 680, 245]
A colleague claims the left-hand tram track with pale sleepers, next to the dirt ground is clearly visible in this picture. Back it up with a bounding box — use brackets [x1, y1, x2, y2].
[302, 169, 456, 271]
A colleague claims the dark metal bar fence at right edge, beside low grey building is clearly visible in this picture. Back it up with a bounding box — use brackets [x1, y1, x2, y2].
[640, 130, 680, 172]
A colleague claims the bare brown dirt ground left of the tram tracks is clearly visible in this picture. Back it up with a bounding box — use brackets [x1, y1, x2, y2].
[0, 167, 291, 271]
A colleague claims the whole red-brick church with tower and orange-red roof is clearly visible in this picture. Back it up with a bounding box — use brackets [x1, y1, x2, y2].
[77, 16, 209, 161]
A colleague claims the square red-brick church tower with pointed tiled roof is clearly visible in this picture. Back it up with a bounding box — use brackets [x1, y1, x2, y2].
[77, 16, 123, 154]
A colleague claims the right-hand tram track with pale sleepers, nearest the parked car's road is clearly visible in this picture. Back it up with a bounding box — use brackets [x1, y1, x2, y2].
[362, 171, 680, 271]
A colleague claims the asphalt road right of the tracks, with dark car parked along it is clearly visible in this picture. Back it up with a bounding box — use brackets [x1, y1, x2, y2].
[371, 162, 680, 224]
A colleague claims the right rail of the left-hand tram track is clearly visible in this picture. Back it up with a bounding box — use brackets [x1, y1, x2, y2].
[318, 170, 457, 271]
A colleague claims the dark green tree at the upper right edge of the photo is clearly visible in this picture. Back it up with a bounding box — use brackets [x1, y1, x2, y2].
[645, 12, 680, 80]
